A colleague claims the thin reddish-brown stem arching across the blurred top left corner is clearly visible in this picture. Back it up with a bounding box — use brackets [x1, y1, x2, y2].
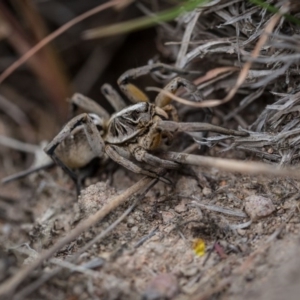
[0, 0, 122, 83]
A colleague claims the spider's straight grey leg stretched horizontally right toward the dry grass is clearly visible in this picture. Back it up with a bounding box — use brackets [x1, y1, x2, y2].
[156, 120, 249, 136]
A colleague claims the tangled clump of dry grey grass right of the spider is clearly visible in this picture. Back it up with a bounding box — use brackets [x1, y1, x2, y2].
[152, 0, 300, 164]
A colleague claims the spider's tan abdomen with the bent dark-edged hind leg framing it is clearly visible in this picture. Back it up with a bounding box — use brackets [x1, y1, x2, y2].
[44, 113, 105, 194]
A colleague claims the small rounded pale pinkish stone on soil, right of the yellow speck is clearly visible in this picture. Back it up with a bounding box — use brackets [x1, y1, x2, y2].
[245, 195, 275, 220]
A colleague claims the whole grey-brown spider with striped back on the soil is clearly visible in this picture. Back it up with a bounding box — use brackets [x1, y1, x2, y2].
[45, 64, 245, 192]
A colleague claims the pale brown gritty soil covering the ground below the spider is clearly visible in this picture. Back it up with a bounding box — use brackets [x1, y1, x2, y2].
[1, 144, 300, 299]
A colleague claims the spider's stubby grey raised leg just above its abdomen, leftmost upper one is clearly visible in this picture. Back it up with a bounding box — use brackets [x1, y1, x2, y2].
[68, 93, 110, 121]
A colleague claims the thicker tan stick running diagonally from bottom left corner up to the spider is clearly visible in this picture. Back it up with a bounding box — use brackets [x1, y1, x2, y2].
[0, 177, 153, 297]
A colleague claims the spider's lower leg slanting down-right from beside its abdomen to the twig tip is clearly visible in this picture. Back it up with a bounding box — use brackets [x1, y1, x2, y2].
[105, 145, 170, 184]
